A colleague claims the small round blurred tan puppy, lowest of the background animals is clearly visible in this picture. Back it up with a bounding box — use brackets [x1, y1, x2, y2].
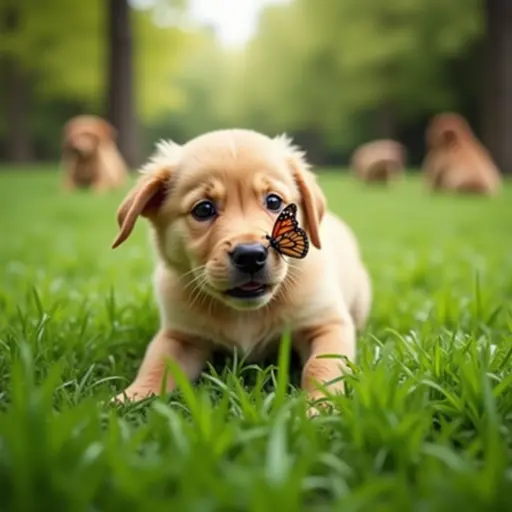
[351, 139, 406, 183]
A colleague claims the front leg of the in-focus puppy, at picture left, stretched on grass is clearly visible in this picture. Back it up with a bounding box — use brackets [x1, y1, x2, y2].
[115, 330, 208, 402]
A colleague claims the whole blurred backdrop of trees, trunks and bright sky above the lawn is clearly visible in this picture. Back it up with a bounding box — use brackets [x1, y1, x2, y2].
[0, 0, 512, 172]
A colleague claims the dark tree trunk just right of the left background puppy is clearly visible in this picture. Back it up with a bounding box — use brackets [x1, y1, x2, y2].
[107, 0, 139, 168]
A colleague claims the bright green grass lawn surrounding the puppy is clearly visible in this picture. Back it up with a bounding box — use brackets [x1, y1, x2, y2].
[0, 171, 512, 512]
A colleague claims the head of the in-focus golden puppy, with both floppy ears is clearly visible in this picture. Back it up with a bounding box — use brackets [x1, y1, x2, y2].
[114, 130, 325, 309]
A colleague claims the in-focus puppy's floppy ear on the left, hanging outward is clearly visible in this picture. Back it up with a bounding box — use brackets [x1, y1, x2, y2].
[112, 142, 180, 249]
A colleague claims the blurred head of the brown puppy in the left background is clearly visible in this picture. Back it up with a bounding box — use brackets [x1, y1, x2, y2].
[63, 116, 115, 158]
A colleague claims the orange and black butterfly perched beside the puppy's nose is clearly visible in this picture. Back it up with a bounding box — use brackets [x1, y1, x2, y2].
[265, 203, 309, 259]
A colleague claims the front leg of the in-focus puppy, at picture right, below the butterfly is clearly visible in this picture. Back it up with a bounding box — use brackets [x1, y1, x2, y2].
[301, 322, 356, 414]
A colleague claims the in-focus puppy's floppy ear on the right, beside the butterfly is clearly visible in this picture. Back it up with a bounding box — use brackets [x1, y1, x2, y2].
[274, 134, 326, 249]
